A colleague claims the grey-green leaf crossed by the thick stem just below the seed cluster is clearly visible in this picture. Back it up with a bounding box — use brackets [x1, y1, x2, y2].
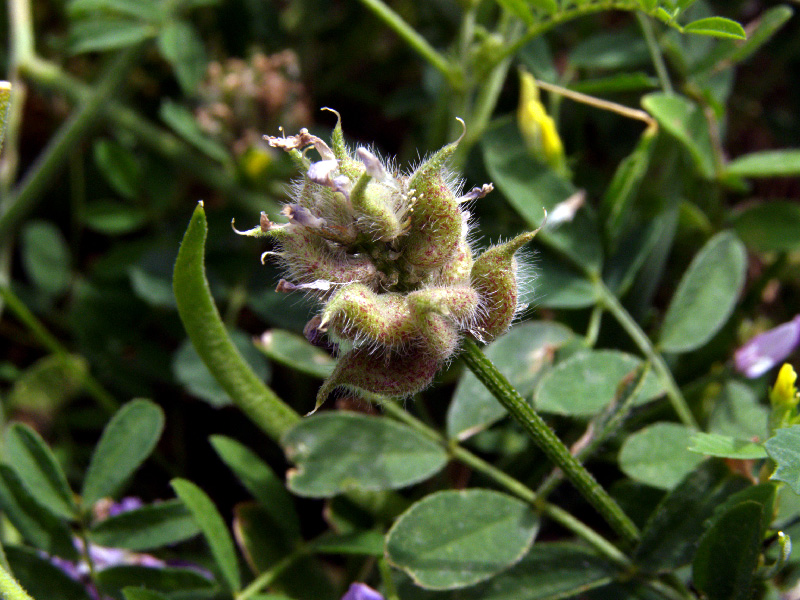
[447, 321, 574, 440]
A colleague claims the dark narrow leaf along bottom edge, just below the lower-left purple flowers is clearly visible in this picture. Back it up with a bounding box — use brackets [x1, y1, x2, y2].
[96, 565, 213, 600]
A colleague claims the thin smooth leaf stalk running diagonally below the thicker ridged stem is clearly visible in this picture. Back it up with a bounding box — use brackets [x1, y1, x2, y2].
[381, 399, 630, 567]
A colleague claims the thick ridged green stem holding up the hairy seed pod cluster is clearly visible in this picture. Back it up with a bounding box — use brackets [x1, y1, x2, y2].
[462, 339, 639, 543]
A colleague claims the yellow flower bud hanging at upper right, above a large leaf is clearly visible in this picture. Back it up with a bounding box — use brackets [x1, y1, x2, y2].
[517, 70, 566, 175]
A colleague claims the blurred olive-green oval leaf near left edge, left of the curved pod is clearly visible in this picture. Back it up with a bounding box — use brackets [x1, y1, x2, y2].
[5, 354, 89, 415]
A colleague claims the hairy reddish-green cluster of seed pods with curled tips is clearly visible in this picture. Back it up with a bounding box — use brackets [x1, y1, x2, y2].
[234, 113, 538, 410]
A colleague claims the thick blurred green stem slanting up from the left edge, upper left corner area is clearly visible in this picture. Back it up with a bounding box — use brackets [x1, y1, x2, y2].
[0, 46, 141, 239]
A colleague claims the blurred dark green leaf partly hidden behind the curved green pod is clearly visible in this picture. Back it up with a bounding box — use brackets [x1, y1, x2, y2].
[172, 331, 270, 408]
